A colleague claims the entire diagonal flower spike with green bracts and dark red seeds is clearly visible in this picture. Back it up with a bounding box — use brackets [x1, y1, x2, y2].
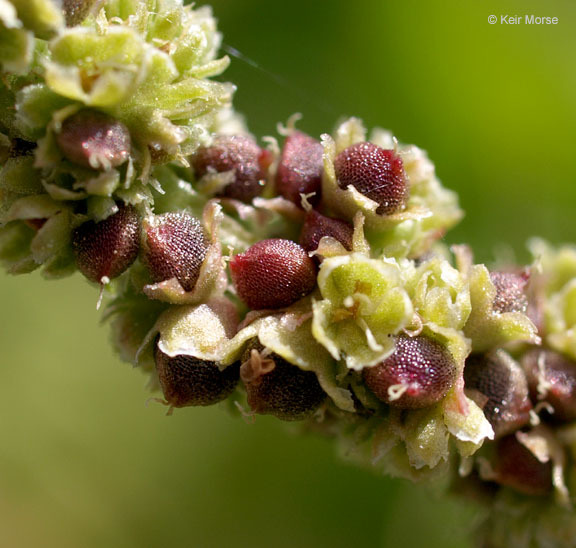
[0, 0, 576, 547]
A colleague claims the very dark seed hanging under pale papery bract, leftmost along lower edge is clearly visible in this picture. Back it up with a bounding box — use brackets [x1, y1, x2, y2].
[154, 346, 240, 407]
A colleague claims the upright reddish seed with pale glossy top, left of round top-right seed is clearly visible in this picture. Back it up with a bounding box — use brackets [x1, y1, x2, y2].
[276, 131, 324, 207]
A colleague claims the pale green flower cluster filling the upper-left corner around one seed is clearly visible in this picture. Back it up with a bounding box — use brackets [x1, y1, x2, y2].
[0, 0, 234, 277]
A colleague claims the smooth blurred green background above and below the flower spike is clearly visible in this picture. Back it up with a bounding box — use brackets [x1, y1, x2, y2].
[0, 0, 576, 548]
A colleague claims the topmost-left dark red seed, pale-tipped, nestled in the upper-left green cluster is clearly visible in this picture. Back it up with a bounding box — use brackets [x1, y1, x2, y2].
[56, 110, 131, 170]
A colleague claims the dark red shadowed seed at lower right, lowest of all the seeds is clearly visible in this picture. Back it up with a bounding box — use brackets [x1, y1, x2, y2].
[494, 435, 552, 496]
